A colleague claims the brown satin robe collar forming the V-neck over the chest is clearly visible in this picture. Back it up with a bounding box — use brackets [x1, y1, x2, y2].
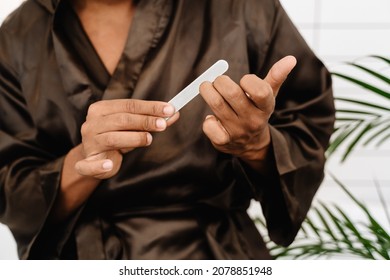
[44, 0, 173, 103]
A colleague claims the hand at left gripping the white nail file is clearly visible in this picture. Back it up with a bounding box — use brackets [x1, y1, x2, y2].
[75, 99, 179, 179]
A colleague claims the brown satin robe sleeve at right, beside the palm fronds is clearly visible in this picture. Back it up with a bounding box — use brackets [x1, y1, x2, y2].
[242, 0, 335, 246]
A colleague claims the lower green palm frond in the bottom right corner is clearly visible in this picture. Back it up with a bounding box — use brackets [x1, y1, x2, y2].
[256, 174, 390, 260]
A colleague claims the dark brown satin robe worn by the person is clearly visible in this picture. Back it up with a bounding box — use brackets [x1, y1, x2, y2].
[0, 0, 334, 259]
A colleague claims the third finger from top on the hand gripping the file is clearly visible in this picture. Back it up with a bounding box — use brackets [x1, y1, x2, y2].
[91, 131, 153, 156]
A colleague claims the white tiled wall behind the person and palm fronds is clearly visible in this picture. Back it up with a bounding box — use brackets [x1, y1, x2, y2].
[0, 0, 390, 259]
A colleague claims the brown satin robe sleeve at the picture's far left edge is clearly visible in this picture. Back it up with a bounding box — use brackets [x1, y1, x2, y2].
[0, 25, 63, 259]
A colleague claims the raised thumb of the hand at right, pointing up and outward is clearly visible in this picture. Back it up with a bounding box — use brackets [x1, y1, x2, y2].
[264, 55, 297, 96]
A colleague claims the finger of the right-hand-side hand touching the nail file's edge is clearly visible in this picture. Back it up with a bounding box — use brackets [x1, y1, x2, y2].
[199, 82, 237, 120]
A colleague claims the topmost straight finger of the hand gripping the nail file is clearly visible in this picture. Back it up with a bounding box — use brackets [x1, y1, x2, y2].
[88, 99, 175, 118]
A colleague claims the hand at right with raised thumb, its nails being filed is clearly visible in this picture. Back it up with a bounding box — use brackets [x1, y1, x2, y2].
[200, 56, 296, 167]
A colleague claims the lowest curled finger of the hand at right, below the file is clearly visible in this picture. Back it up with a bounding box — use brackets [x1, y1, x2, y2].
[203, 115, 230, 146]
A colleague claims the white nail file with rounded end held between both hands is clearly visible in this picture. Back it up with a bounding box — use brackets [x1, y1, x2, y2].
[168, 60, 229, 112]
